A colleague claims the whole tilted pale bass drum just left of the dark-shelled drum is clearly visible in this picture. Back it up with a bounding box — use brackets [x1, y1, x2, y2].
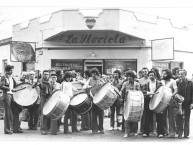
[43, 90, 70, 120]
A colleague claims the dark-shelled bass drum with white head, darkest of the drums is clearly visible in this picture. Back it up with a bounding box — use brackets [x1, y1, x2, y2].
[70, 91, 92, 115]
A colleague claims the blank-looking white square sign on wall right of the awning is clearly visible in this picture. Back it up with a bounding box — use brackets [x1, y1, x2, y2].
[151, 38, 174, 60]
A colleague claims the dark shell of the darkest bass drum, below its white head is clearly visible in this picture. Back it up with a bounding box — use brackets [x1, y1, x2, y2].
[70, 93, 92, 115]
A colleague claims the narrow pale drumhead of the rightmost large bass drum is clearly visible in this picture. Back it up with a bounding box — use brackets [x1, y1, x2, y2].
[149, 86, 164, 110]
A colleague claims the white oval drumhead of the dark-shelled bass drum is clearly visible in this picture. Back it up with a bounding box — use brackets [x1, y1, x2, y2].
[70, 93, 87, 106]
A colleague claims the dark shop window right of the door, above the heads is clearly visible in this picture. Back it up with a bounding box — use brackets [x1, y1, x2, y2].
[105, 59, 137, 74]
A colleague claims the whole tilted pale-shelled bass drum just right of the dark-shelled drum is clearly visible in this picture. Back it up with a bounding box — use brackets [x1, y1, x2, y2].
[93, 83, 118, 110]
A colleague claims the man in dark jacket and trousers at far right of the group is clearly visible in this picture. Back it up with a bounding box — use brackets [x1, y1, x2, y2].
[176, 69, 193, 139]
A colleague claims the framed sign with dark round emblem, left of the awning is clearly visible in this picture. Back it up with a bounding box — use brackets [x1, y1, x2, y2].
[10, 41, 36, 62]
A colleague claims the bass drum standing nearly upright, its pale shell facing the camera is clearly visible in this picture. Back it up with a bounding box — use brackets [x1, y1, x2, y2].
[123, 90, 144, 122]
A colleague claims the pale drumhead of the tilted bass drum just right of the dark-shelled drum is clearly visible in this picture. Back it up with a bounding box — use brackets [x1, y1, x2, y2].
[93, 83, 110, 104]
